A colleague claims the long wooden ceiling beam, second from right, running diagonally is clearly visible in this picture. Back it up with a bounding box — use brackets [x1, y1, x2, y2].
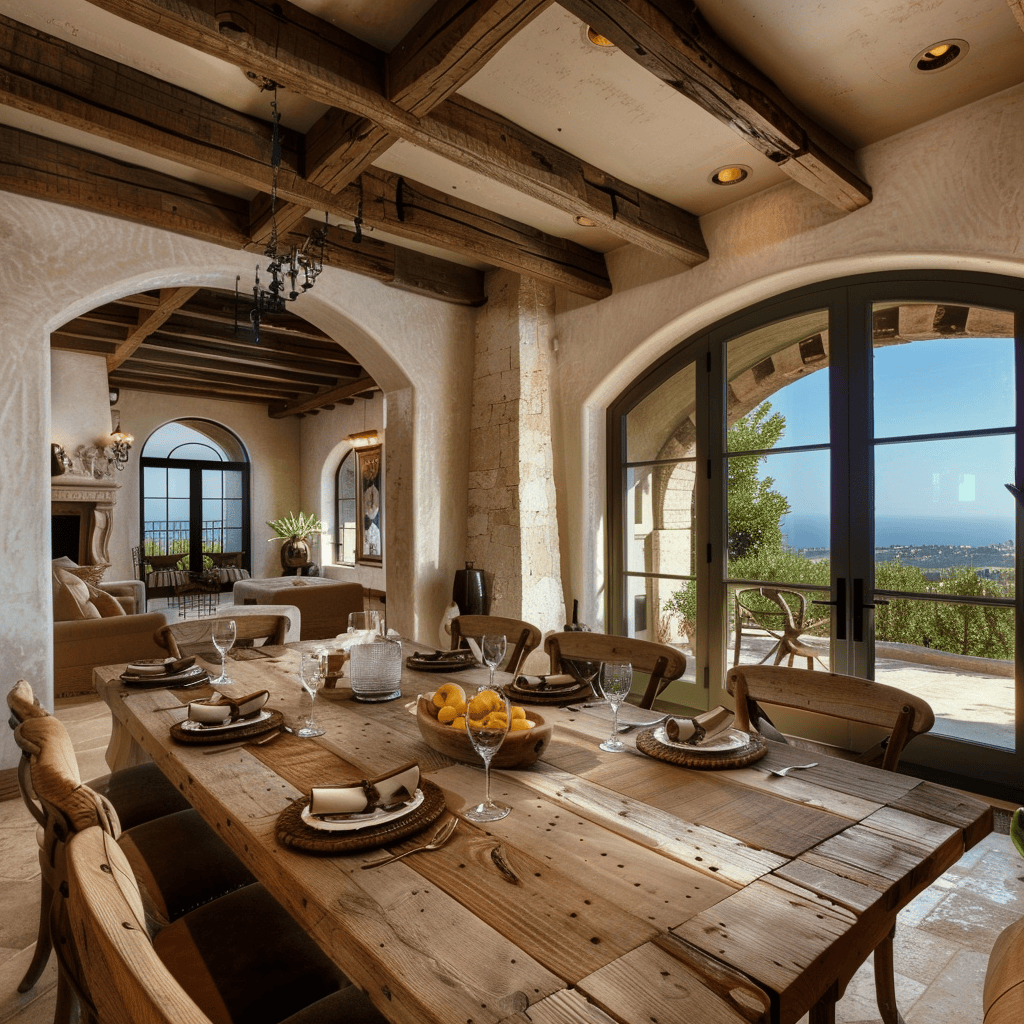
[89, 0, 707, 265]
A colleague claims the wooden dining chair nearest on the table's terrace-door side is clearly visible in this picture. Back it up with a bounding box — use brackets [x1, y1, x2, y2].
[726, 665, 935, 1024]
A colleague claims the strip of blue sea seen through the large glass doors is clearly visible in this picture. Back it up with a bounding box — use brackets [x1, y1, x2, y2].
[781, 514, 1014, 549]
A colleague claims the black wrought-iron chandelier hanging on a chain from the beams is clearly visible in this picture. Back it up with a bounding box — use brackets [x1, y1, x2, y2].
[234, 79, 330, 344]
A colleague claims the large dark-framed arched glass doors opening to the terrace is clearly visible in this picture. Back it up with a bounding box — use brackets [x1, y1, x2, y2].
[608, 273, 1024, 781]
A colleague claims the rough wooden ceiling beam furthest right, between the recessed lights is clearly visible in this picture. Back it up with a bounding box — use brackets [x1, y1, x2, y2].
[558, 0, 871, 211]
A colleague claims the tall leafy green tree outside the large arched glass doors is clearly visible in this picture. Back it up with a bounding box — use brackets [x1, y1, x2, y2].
[726, 401, 790, 561]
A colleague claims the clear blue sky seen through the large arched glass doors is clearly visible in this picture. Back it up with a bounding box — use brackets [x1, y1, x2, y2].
[761, 338, 1014, 519]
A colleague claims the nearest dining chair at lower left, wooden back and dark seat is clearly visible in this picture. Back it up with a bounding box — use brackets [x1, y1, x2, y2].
[54, 826, 387, 1024]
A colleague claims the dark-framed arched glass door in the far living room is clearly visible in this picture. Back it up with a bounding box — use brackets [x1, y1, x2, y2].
[140, 419, 251, 571]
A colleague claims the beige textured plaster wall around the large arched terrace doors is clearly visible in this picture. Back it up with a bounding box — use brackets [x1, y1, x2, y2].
[556, 81, 1024, 679]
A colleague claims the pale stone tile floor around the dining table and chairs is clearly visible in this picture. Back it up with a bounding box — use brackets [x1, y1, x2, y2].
[0, 697, 1024, 1024]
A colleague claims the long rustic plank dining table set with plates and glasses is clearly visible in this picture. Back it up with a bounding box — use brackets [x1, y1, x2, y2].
[95, 642, 991, 1024]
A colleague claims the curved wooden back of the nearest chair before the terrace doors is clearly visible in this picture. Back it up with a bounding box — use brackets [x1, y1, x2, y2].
[726, 665, 935, 771]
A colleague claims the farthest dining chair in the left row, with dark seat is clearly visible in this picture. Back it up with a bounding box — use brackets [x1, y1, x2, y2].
[7, 679, 189, 992]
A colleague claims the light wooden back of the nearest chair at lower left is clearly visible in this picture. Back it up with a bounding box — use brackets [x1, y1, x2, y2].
[62, 827, 210, 1024]
